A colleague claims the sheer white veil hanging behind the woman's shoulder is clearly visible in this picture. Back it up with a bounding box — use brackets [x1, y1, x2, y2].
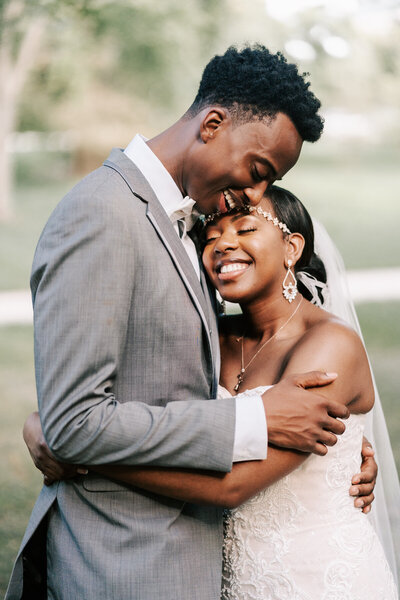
[313, 220, 400, 585]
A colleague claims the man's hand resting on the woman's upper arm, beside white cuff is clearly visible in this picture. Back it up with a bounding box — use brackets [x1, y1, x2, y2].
[263, 371, 349, 456]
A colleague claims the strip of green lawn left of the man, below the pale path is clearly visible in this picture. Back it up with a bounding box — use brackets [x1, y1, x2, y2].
[0, 326, 41, 597]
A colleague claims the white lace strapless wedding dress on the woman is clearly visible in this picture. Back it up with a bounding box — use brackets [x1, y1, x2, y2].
[221, 387, 397, 600]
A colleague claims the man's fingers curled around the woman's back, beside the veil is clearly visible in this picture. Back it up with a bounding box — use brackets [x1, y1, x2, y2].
[350, 438, 378, 513]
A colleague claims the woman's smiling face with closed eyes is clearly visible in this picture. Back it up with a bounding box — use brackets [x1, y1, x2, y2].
[203, 200, 290, 304]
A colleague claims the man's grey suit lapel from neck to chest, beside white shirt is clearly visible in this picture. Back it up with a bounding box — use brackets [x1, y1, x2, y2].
[104, 149, 218, 365]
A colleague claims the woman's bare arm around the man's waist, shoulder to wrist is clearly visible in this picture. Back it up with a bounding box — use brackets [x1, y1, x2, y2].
[89, 322, 373, 507]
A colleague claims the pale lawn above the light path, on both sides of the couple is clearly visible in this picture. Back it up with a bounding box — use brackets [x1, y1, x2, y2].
[0, 141, 400, 290]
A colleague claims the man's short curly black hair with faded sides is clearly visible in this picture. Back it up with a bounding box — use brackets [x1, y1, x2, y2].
[187, 44, 323, 142]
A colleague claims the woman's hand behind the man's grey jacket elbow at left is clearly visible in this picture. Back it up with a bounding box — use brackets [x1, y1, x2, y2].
[23, 412, 87, 485]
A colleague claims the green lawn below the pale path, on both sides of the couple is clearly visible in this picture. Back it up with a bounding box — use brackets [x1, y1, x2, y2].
[0, 302, 400, 595]
